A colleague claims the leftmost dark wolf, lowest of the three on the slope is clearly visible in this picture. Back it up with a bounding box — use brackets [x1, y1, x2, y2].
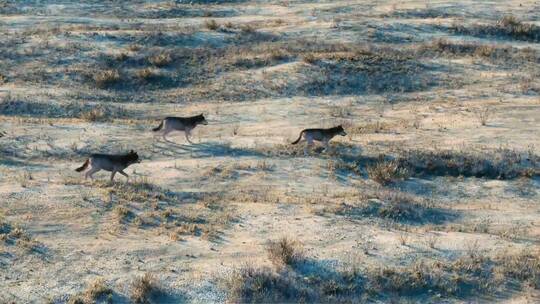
[75, 150, 141, 181]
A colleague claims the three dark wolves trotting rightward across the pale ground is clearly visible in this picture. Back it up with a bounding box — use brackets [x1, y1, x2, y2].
[75, 114, 347, 181]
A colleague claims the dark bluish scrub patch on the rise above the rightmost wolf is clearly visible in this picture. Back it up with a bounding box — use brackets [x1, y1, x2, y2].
[299, 49, 437, 95]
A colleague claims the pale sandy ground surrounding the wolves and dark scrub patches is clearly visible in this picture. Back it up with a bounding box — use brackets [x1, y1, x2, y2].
[0, 0, 540, 303]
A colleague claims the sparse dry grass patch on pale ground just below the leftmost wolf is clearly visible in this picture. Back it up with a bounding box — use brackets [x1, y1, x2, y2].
[64, 178, 234, 241]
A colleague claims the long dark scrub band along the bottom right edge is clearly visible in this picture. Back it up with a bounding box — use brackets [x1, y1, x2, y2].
[224, 250, 540, 303]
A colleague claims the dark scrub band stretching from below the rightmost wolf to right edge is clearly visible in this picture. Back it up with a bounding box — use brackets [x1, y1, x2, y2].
[259, 143, 540, 180]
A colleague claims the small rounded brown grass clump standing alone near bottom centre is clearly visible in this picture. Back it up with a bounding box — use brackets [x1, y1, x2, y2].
[266, 237, 304, 266]
